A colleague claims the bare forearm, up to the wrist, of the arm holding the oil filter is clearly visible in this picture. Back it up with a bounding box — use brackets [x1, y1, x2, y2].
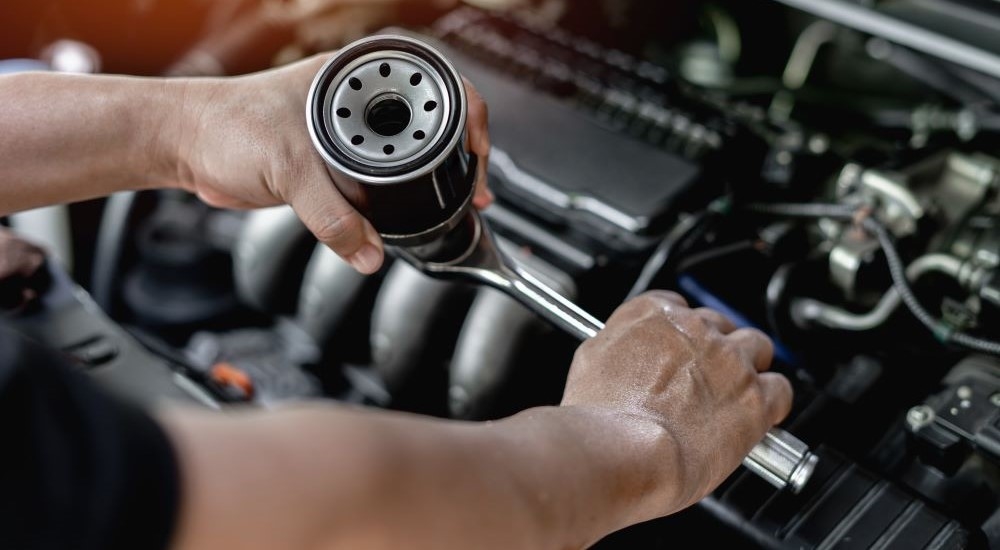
[0, 73, 183, 215]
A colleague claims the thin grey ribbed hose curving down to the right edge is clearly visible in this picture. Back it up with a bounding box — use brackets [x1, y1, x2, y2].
[745, 204, 1000, 355]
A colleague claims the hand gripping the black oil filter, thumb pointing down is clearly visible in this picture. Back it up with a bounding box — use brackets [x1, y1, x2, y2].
[171, 55, 492, 273]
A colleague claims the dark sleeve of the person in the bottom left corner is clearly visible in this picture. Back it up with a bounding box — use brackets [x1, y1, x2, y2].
[0, 326, 179, 550]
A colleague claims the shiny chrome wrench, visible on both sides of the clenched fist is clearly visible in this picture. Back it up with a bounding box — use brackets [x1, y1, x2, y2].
[395, 211, 819, 493]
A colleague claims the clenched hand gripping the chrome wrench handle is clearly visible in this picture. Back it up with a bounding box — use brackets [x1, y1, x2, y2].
[562, 292, 792, 521]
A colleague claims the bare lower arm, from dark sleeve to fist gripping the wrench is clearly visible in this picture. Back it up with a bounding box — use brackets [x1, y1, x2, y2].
[165, 293, 791, 550]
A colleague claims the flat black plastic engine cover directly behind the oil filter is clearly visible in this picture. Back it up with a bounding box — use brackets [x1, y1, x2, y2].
[430, 12, 702, 254]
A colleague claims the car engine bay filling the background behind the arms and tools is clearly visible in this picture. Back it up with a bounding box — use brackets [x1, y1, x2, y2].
[0, 0, 1000, 549]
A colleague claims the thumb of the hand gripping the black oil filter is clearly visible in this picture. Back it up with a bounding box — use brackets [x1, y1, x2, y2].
[288, 165, 385, 275]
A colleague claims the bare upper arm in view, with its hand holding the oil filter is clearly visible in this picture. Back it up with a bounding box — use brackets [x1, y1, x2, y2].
[0, 56, 491, 273]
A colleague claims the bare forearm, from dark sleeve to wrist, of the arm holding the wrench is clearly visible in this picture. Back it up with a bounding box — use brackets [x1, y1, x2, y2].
[167, 407, 672, 549]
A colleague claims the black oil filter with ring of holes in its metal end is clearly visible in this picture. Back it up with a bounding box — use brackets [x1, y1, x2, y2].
[306, 35, 476, 247]
